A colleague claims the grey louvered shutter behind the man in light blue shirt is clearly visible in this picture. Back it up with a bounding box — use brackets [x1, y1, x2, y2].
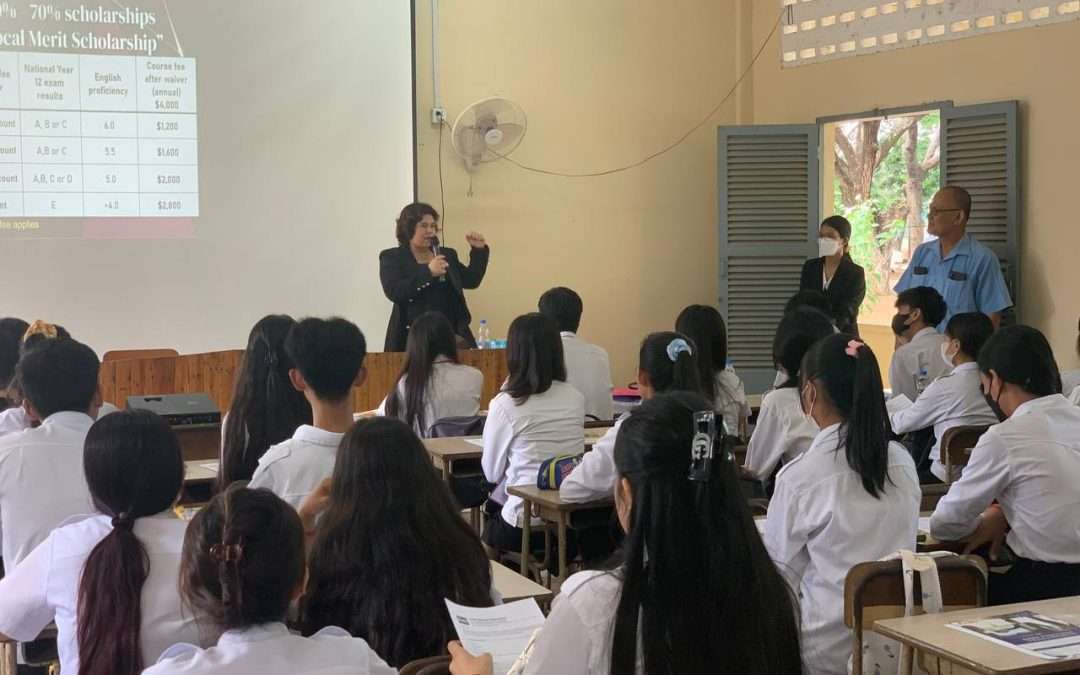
[941, 100, 1020, 302]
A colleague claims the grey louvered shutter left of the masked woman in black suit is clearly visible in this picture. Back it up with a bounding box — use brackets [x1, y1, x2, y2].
[717, 124, 820, 392]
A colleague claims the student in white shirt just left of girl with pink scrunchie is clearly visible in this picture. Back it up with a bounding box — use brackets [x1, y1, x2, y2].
[743, 307, 836, 481]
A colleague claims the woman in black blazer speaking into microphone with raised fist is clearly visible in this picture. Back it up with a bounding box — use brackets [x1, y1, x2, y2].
[379, 203, 491, 352]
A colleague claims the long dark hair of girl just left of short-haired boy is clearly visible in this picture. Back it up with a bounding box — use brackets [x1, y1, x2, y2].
[218, 314, 311, 490]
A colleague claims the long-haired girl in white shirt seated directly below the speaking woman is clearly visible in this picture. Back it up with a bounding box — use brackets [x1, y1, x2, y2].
[378, 312, 484, 437]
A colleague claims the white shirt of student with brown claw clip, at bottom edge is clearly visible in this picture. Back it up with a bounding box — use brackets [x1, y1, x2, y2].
[143, 623, 397, 675]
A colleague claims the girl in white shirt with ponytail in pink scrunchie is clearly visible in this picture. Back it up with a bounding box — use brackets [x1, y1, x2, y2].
[765, 335, 924, 675]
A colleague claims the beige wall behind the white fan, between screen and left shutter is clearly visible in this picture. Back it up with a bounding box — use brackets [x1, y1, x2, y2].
[416, 0, 751, 384]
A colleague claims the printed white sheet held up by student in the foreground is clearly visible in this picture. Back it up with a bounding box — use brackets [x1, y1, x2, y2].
[446, 598, 543, 675]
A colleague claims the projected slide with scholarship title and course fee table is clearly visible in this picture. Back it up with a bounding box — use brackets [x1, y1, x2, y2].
[0, 1, 199, 232]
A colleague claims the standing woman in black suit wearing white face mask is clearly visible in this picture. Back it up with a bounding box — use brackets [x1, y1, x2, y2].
[799, 216, 866, 335]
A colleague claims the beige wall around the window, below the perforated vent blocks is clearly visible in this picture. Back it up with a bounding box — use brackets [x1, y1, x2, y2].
[742, 0, 1080, 368]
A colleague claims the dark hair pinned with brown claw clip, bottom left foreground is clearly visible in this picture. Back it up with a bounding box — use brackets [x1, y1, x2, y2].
[180, 484, 305, 630]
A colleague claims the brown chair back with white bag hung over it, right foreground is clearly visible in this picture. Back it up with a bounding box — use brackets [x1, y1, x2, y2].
[843, 555, 987, 675]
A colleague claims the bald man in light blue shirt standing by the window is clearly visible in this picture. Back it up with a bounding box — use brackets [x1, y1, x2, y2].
[894, 186, 1012, 332]
